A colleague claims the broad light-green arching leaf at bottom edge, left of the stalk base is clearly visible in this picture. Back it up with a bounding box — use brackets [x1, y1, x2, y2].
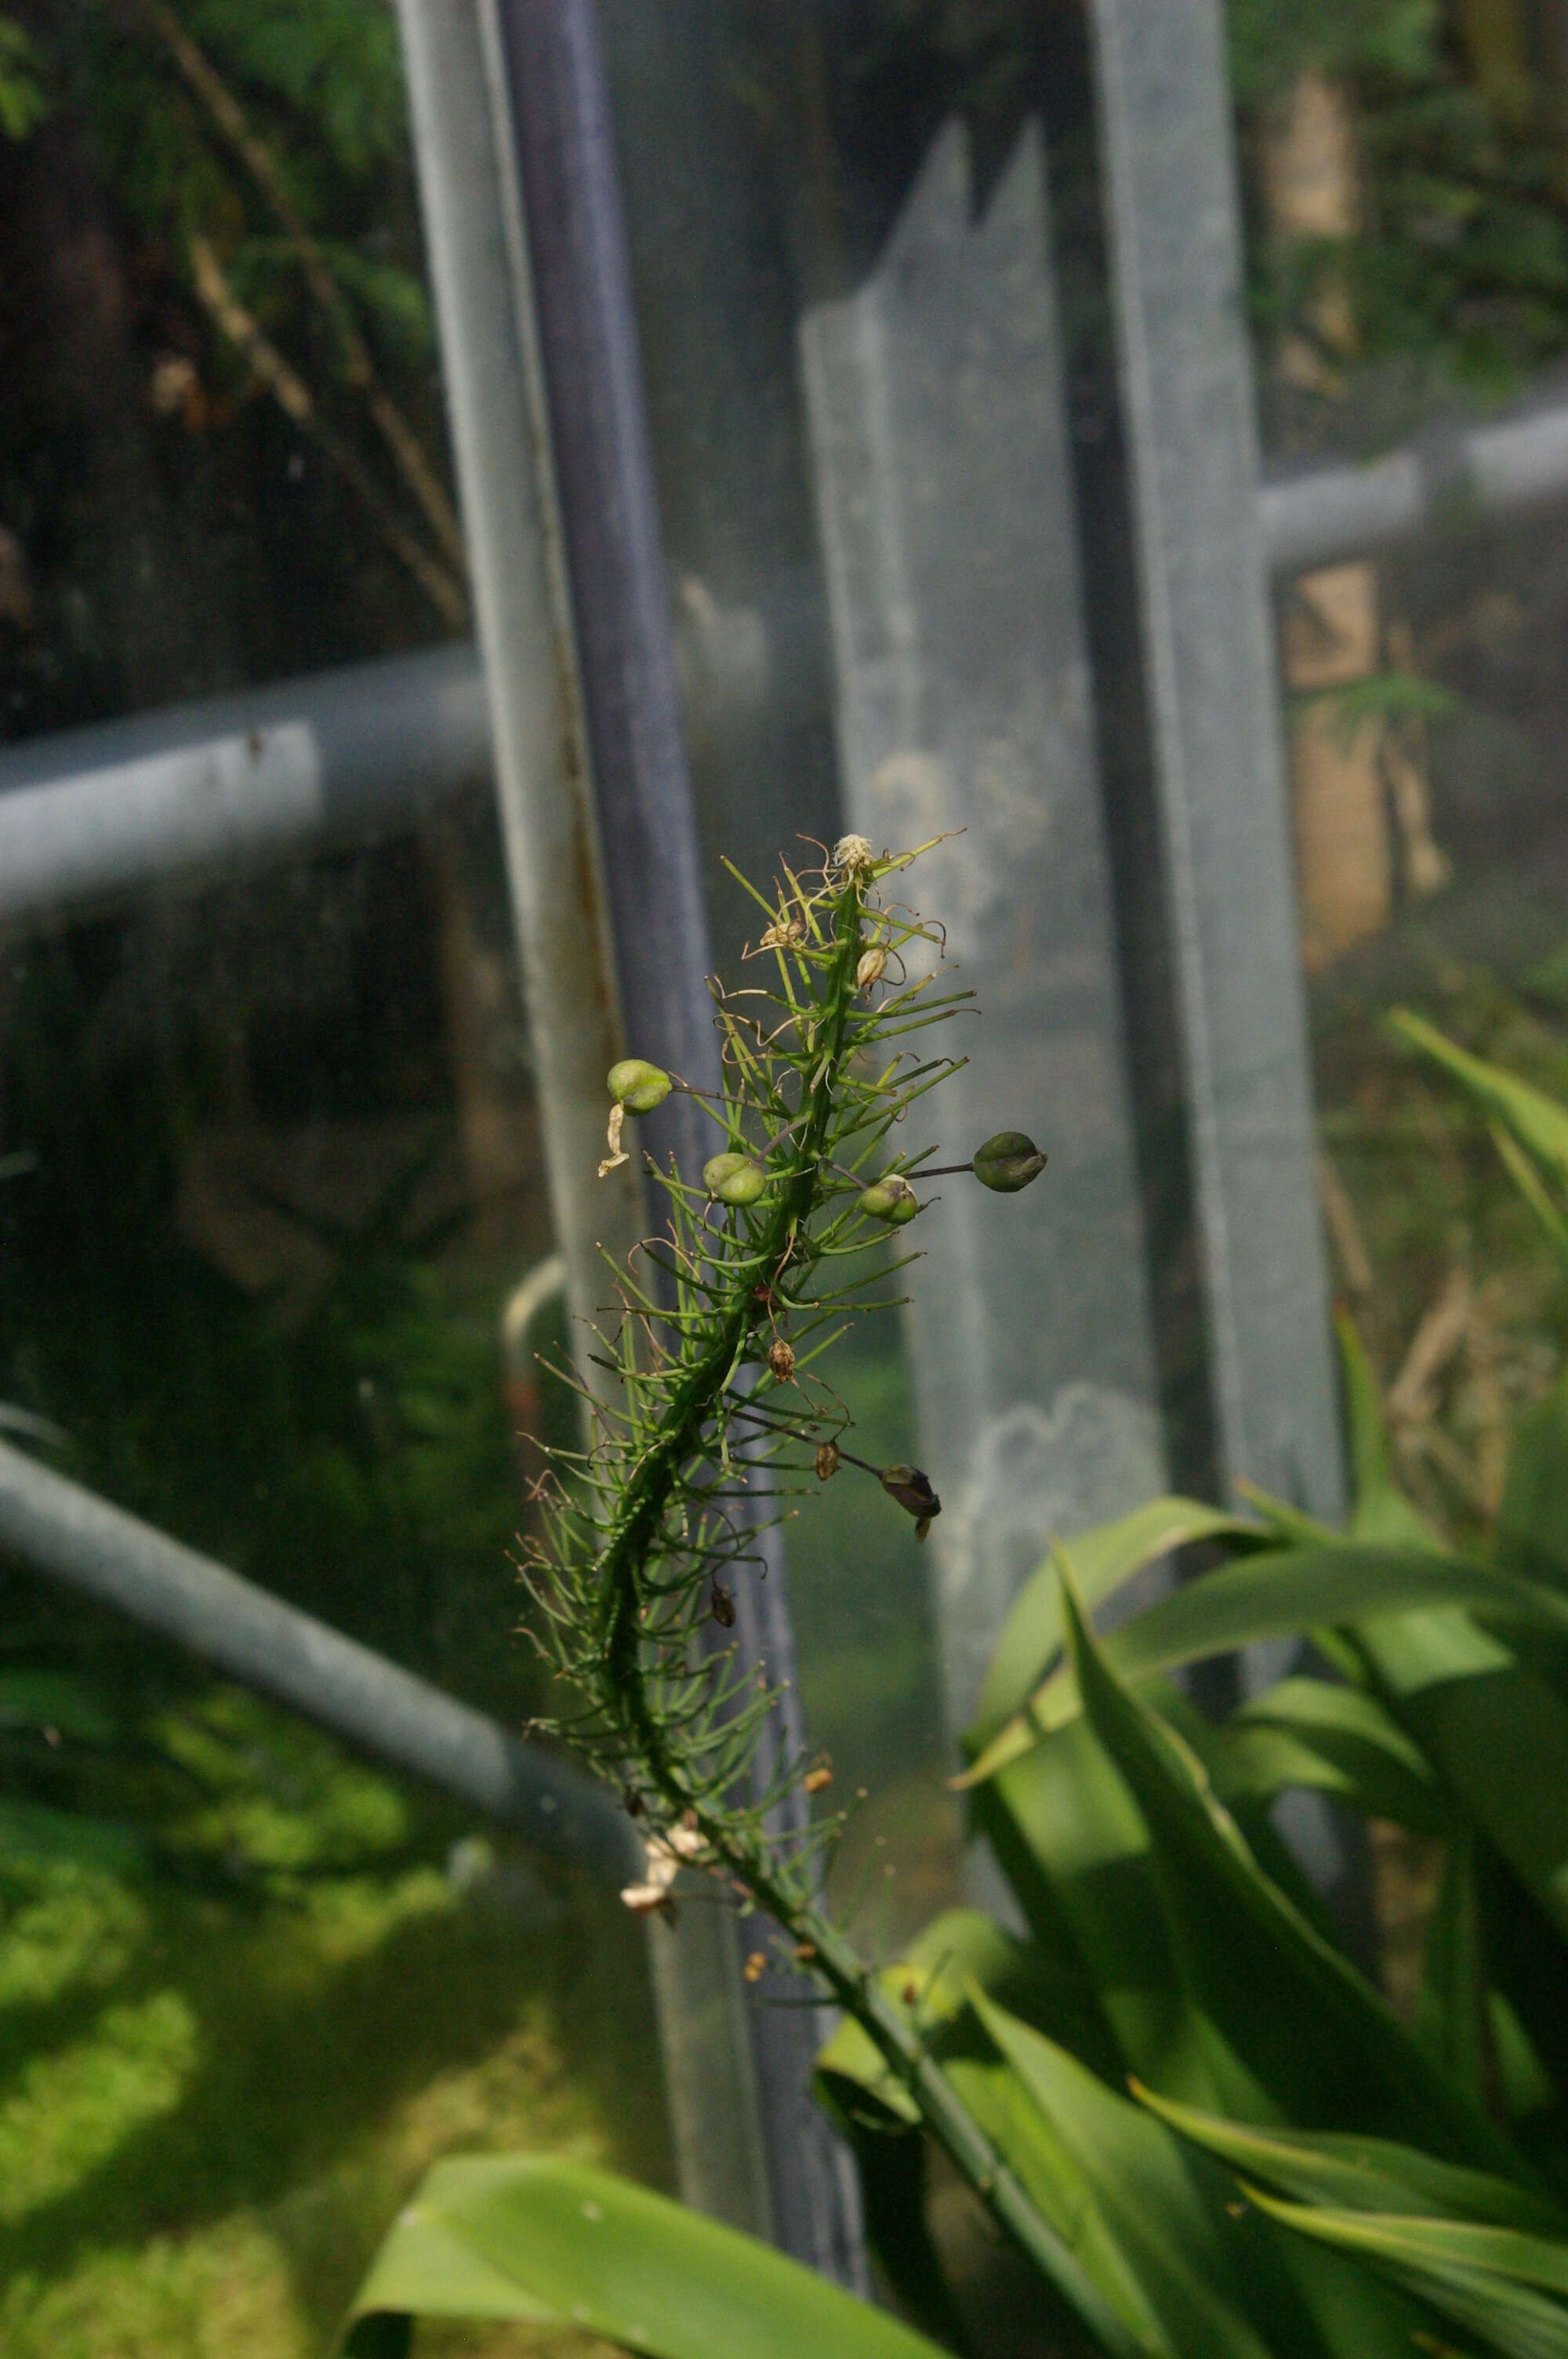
[344, 2154, 938, 2359]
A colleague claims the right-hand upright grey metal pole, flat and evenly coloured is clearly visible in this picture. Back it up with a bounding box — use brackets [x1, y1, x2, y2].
[1094, 0, 1344, 1517]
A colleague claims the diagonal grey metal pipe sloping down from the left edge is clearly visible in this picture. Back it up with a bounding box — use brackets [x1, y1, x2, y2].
[0, 1441, 641, 1885]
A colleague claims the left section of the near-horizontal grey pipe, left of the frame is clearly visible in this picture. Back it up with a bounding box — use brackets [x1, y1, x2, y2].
[0, 644, 491, 929]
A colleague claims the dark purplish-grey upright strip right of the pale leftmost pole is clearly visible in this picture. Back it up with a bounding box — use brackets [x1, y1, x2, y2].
[483, 0, 866, 2286]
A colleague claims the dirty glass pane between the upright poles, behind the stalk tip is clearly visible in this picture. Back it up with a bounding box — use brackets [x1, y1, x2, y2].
[604, 0, 1165, 1930]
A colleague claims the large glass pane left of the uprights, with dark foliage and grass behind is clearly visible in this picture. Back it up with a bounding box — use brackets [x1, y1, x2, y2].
[0, 0, 667, 2359]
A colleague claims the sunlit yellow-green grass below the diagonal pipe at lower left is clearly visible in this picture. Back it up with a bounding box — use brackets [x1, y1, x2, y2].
[0, 1703, 667, 2359]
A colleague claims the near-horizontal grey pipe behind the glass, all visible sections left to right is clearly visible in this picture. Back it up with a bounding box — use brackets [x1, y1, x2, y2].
[0, 363, 1568, 934]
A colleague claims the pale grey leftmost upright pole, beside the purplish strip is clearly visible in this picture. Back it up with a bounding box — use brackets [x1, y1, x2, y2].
[398, 0, 858, 2274]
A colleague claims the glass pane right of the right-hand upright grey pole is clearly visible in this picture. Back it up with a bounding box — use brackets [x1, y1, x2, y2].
[1229, 0, 1568, 2001]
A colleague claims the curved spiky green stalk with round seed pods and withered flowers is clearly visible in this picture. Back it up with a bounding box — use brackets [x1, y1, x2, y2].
[524, 835, 1132, 2352]
